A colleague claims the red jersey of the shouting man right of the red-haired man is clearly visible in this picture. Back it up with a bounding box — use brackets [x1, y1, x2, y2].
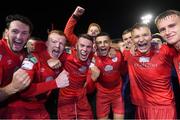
[60, 49, 91, 97]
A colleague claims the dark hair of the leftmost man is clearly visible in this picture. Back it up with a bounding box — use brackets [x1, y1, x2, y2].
[6, 14, 33, 33]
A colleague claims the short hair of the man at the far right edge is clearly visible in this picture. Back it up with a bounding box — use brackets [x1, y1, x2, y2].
[155, 10, 180, 25]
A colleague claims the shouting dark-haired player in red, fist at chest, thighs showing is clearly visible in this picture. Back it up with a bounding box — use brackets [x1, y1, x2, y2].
[87, 32, 125, 119]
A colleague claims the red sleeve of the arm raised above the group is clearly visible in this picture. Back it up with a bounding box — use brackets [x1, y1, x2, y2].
[64, 16, 78, 46]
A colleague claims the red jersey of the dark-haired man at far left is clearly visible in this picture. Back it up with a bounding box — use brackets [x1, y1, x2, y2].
[0, 39, 26, 87]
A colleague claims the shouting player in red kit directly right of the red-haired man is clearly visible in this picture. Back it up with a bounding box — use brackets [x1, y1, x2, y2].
[58, 34, 93, 119]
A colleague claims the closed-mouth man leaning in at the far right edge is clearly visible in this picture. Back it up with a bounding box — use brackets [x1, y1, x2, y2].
[155, 10, 180, 84]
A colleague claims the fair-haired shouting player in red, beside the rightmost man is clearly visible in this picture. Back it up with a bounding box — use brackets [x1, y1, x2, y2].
[124, 24, 176, 119]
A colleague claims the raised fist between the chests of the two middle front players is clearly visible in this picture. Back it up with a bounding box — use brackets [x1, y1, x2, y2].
[90, 65, 100, 82]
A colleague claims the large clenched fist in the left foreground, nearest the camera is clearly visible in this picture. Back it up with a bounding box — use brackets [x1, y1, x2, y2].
[10, 69, 31, 93]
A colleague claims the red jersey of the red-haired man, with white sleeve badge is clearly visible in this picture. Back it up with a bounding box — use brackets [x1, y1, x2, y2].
[10, 50, 66, 108]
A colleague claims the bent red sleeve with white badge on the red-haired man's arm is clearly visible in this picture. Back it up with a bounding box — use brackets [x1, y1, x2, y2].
[20, 54, 57, 97]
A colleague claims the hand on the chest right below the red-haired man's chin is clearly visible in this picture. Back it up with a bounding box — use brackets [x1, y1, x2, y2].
[47, 58, 61, 69]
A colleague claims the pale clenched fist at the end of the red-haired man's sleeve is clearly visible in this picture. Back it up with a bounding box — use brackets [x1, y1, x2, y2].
[55, 70, 69, 88]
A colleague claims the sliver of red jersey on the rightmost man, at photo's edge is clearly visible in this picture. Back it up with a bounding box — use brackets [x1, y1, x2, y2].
[173, 52, 180, 84]
